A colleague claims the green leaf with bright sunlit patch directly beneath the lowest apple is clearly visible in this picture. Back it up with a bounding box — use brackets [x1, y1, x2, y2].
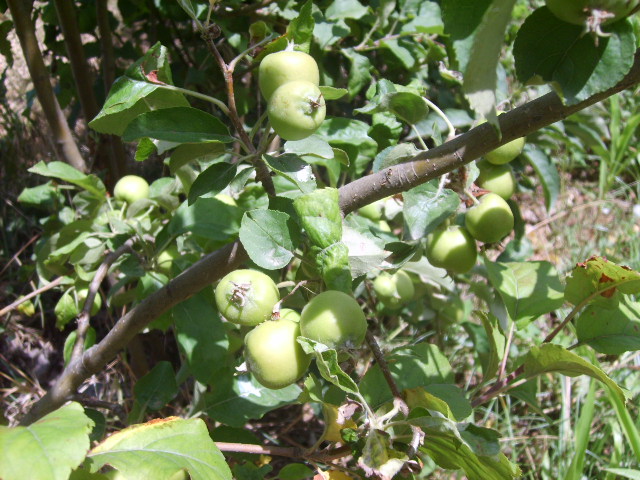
[205, 372, 302, 427]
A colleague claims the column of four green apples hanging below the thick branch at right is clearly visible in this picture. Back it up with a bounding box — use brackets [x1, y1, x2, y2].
[425, 113, 525, 273]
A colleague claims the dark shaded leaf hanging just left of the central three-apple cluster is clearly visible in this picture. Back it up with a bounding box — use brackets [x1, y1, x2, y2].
[173, 293, 229, 384]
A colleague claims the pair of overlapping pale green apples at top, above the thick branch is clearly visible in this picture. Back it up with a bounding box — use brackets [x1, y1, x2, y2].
[258, 45, 326, 140]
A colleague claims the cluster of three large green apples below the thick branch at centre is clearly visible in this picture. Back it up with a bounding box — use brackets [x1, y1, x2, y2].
[215, 269, 367, 389]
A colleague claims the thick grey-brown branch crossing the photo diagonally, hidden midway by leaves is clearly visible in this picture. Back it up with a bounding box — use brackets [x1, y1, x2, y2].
[21, 47, 640, 424]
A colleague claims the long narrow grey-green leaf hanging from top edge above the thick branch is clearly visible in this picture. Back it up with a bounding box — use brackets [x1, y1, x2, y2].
[462, 0, 516, 117]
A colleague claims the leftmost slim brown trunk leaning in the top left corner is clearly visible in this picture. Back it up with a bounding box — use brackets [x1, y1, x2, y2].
[7, 0, 87, 173]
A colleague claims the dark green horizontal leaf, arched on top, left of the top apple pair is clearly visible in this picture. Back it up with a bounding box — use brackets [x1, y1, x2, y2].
[122, 107, 233, 143]
